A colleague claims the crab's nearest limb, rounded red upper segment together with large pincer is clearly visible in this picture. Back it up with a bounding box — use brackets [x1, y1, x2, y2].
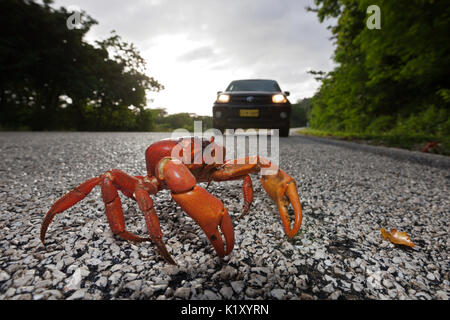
[155, 157, 234, 257]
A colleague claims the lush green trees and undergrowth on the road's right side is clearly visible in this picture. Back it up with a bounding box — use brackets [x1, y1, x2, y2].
[309, 0, 450, 150]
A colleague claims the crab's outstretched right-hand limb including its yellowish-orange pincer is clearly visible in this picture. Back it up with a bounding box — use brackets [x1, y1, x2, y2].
[210, 156, 302, 238]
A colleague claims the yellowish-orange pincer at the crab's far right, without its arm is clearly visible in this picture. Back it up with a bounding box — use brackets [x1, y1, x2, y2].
[261, 169, 302, 238]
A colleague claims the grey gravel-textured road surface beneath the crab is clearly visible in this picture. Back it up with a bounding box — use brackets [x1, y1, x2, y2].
[0, 133, 450, 300]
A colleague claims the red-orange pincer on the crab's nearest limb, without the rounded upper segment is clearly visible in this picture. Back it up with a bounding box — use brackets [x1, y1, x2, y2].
[172, 186, 234, 258]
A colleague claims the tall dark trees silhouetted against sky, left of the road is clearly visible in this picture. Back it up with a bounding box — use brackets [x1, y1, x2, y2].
[0, 0, 163, 131]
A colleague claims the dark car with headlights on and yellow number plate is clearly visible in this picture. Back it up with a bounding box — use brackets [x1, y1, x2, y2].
[213, 79, 291, 137]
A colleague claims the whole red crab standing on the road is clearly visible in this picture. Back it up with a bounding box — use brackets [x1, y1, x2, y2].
[41, 137, 302, 264]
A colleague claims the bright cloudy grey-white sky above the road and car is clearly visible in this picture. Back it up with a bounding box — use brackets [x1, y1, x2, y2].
[53, 0, 335, 115]
